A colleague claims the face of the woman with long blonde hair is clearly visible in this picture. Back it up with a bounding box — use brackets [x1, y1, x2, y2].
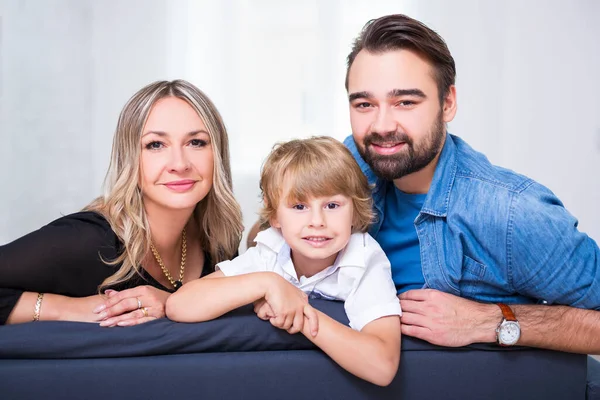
[139, 97, 214, 214]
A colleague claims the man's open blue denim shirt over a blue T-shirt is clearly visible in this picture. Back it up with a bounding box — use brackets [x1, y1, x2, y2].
[344, 134, 600, 310]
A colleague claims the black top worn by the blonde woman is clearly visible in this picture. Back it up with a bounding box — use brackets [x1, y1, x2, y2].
[0, 211, 213, 325]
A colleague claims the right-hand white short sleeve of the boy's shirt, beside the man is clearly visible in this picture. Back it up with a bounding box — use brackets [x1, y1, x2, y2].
[344, 234, 402, 331]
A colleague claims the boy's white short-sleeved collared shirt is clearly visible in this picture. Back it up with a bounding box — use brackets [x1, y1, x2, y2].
[216, 228, 402, 331]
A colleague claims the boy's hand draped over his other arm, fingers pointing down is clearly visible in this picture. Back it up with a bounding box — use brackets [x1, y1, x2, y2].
[265, 275, 314, 334]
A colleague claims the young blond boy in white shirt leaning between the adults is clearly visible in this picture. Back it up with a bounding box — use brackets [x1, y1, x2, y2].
[167, 137, 402, 386]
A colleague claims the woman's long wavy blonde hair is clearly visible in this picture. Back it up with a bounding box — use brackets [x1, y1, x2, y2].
[85, 80, 243, 289]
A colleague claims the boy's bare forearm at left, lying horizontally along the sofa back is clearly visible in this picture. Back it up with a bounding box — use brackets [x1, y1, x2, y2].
[166, 272, 273, 322]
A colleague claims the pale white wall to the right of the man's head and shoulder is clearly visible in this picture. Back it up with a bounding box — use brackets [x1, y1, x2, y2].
[411, 0, 600, 241]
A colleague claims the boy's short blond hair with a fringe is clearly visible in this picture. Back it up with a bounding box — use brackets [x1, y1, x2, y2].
[260, 136, 374, 232]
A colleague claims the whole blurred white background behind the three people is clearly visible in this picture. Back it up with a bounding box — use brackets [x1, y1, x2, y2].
[0, 0, 600, 250]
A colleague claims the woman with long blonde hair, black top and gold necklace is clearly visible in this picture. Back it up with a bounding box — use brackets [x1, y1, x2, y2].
[0, 80, 242, 326]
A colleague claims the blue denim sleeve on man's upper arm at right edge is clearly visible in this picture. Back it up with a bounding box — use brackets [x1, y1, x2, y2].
[507, 183, 600, 310]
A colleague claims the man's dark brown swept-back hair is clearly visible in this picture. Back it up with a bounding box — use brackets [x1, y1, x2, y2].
[346, 14, 456, 103]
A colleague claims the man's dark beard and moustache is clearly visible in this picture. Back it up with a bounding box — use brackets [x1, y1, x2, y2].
[356, 111, 446, 181]
